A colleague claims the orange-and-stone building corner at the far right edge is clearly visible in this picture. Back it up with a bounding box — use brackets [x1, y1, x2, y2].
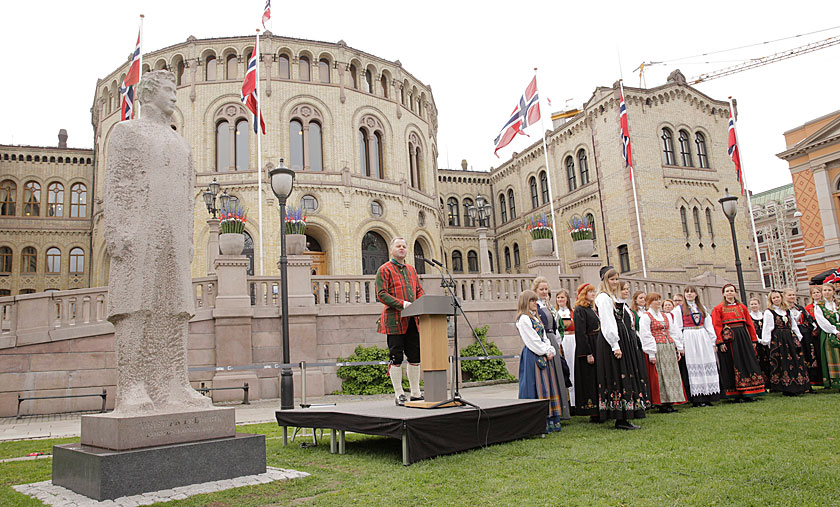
[777, 111, 840, 277]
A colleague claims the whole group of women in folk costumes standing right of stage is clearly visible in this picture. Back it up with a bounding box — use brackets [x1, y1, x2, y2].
[516, 266, 840, 431]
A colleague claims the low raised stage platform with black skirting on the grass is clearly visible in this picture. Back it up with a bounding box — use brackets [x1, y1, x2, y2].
[277, 398, 548, 465]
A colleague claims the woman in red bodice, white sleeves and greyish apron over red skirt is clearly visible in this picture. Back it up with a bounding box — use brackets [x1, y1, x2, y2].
[639, 292, 685, 414]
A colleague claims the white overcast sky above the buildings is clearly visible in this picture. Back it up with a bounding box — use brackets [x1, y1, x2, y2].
[0, 0, 840, 192]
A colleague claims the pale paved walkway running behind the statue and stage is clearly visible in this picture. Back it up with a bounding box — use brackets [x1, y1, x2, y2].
[0, 383, 519, 442]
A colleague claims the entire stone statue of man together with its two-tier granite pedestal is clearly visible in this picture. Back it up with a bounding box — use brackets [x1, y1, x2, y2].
[52, 71, 266, 500]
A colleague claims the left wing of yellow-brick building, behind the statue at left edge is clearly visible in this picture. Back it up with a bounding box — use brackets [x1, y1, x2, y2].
[0, 130, 93, 296]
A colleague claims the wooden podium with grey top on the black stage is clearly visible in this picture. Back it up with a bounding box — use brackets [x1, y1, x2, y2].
[400, 295, 455, 408]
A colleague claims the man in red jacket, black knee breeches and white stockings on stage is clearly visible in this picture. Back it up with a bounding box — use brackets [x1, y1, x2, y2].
[376, 237, 423, 406]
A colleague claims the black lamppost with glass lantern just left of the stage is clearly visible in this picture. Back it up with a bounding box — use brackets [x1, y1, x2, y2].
[268, 158, 295, 410]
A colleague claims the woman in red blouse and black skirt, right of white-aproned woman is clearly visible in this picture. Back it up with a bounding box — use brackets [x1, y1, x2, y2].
[712, 283, 764, 402]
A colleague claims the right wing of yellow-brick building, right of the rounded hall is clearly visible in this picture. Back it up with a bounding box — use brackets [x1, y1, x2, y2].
[438, 72, 760, 283]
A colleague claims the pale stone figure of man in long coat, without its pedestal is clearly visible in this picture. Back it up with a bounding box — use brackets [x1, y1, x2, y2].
[104, 71, 211, 414]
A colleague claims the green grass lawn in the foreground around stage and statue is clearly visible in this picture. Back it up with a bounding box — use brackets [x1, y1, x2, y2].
[0, 391, 840, 507]
